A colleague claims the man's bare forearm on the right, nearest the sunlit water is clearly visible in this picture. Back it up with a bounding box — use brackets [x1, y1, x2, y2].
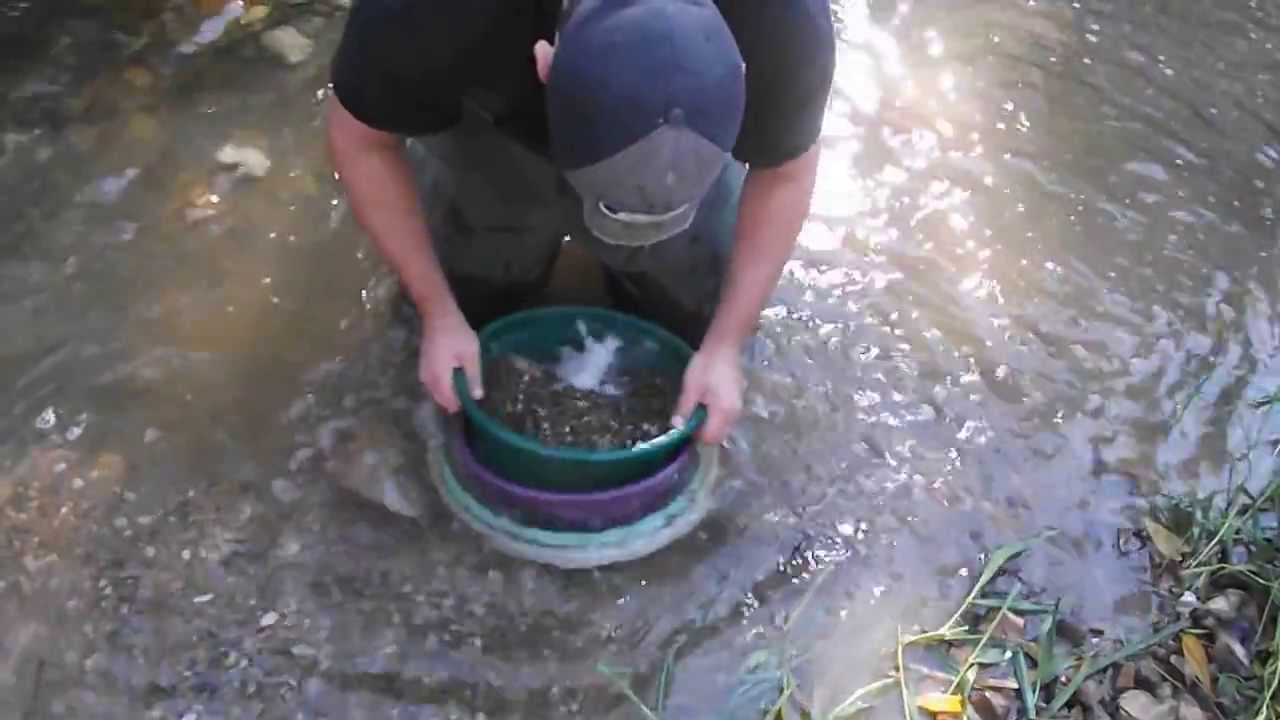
[703, 145, 818, 351]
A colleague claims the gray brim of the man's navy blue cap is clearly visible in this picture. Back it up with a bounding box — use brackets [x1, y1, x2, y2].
[564, 124, 730, 246]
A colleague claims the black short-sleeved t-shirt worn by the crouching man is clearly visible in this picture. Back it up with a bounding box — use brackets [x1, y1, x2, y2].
[332, 0, 835, 167]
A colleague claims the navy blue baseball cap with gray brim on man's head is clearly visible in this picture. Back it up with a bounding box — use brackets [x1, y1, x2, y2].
[547, 0, 746, 246]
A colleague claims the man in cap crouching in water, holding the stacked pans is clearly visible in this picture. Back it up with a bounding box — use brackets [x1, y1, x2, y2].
[328, 0, 835, 443]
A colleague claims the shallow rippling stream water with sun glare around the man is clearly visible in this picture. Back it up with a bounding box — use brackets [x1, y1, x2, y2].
[0, 0, 1280, 719]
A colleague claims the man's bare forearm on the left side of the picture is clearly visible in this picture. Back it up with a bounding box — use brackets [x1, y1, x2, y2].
[329, 97, 457, 319]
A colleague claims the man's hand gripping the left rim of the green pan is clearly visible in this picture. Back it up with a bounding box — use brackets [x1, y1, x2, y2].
[417, 309, 484, 414]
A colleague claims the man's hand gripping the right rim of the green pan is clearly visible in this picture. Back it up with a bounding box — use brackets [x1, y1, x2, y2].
[672, 347, 746, 445]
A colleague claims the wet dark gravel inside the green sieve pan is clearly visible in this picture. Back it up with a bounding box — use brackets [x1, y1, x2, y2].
[480, 356, 678, 450]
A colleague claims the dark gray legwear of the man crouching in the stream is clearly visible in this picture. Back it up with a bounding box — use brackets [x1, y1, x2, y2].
[407, 110, 746, 347]
